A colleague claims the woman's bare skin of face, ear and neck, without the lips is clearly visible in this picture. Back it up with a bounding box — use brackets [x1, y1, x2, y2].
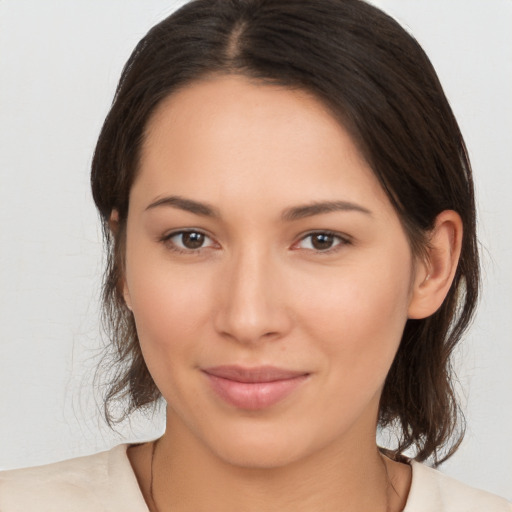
[121, 76, 462, 512]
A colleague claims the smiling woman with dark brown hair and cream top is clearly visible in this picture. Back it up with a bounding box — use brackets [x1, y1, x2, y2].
[0, 0, 510, 512]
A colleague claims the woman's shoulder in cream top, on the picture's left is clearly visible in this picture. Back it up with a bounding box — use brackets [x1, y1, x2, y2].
[0, 445, 147, 512]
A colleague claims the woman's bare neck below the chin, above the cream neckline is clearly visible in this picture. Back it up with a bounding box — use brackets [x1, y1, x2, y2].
[147, 412, 400, 512]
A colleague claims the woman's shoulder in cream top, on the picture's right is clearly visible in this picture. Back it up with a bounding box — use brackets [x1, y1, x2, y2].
[404, 461, 512, 512]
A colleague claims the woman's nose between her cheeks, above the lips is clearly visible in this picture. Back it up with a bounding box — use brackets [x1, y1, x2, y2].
[214, 247, 292, 344]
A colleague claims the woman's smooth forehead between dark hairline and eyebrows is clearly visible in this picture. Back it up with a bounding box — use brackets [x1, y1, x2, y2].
[136, 76, 387, 214]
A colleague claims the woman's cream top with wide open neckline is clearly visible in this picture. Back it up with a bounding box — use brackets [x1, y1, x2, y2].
[0, 444, 512, 512]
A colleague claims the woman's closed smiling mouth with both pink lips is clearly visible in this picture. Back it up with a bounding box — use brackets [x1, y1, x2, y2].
[202, 366, 310, 411]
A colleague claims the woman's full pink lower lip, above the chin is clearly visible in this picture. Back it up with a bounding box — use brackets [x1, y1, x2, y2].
[205, 373, 308, 411]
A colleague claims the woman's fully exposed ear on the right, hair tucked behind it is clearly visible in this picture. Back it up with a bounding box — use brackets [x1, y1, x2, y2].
[408, 210, 463, 319]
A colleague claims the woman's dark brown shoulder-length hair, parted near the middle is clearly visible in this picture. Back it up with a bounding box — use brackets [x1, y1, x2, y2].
[91, 0, 479, 464]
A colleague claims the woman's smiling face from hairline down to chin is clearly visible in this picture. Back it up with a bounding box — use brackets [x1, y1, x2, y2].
[124, 76, 420, 467]
